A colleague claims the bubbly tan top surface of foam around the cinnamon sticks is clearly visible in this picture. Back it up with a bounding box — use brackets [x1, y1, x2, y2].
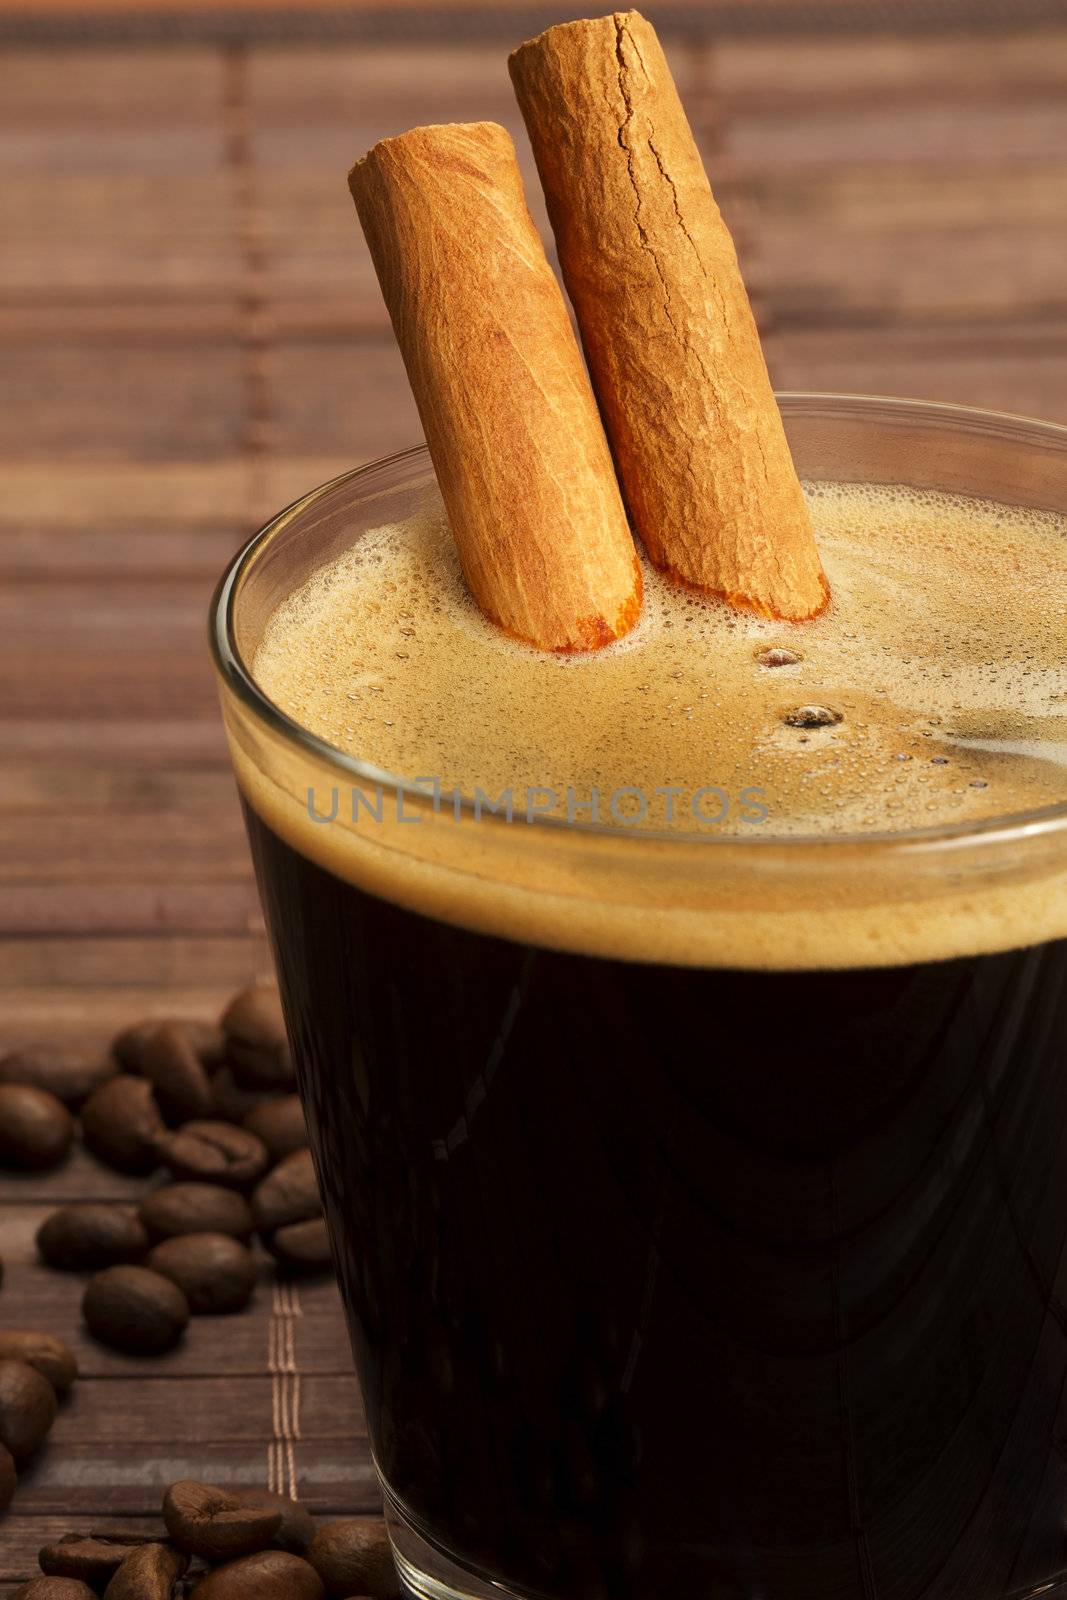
[254, 485, 1067, 835]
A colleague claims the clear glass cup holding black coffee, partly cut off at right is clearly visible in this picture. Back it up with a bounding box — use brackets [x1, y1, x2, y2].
[211, 395, 1067, 1600]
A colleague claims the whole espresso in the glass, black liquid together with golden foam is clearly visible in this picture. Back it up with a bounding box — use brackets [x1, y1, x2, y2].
[234, 485, 1067, 1600]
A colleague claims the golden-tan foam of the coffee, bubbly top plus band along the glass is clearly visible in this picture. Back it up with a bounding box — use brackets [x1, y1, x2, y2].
[238, 483, 1067, 966]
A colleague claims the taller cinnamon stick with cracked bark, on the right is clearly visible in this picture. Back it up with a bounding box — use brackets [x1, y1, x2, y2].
[509, 11, 829, 621]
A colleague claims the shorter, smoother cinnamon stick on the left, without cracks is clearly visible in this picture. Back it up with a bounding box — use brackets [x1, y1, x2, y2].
[349, 122, 641, 650]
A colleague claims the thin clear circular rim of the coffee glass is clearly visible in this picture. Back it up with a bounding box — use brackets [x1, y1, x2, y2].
[208, 389, 1067, 856]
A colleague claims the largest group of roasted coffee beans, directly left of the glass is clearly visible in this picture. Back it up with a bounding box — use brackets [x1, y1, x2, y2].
[0, 986, 330, 1355]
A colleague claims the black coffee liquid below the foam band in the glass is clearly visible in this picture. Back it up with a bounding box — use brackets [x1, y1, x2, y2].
[246, 810, 1067, 1600]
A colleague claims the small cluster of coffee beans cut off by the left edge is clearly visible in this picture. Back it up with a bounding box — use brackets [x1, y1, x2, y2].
[0, 1328, 78, 1512]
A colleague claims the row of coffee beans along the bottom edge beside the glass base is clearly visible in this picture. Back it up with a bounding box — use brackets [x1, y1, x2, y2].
[16, 1480, 400, 1600]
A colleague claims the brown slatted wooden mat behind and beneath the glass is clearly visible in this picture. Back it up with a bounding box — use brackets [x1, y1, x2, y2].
[0, 0, 1067, 1594]
